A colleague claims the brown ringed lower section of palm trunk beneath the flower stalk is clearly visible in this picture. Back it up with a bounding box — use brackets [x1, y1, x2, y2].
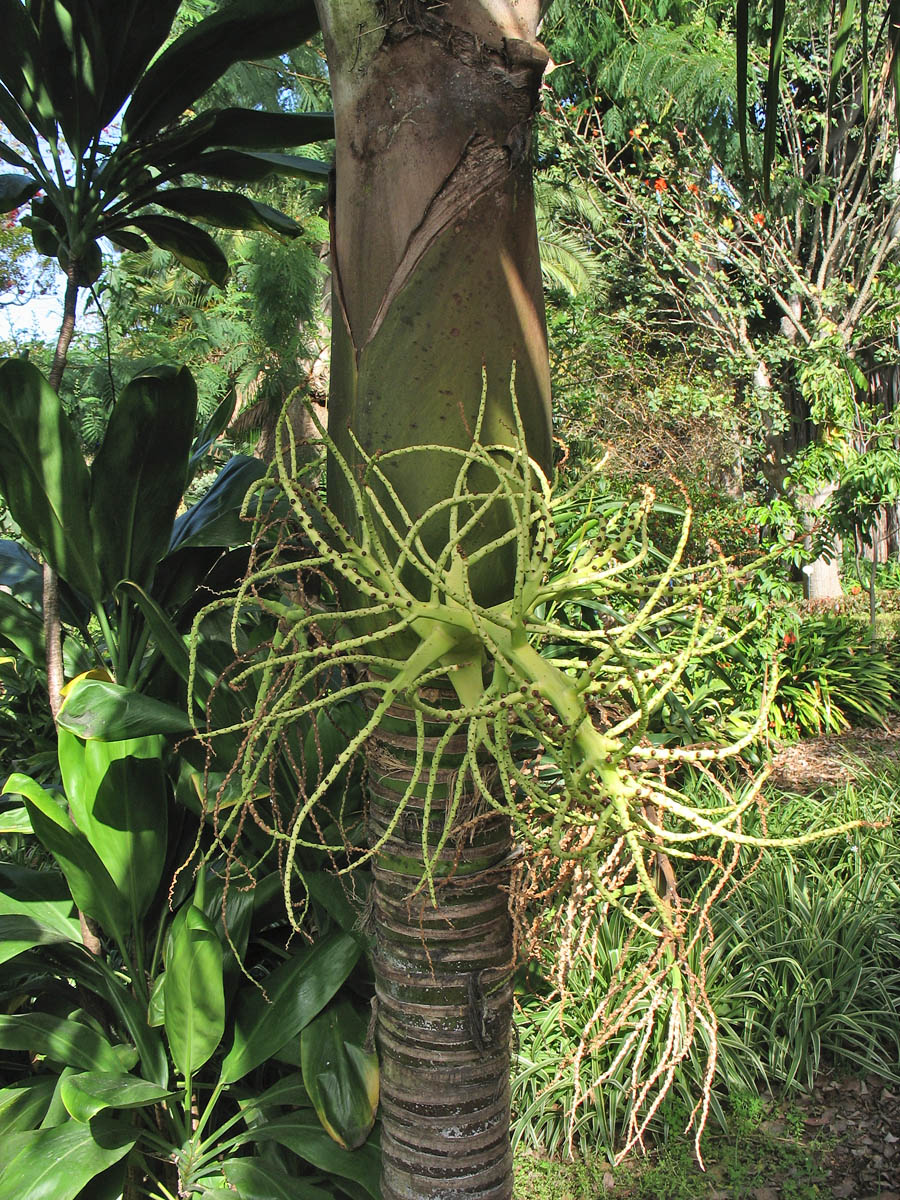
[368, 694, 514, 1200]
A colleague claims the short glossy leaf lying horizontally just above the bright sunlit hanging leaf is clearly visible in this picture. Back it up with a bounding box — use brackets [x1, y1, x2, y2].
[59, 679, 193, 742]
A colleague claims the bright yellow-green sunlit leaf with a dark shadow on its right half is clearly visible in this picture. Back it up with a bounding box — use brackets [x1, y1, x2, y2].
[58, 720, 168, 931]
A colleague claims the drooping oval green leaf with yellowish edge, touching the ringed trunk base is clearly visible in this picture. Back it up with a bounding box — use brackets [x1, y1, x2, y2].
[300, 1001, 378, 1150]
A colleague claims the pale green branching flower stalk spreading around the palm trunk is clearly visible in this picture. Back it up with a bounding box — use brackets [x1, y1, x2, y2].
[188, 391, 868, 1148]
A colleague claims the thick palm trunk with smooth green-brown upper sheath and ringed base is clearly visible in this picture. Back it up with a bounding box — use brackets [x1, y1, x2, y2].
[319, 0, 551, 1200]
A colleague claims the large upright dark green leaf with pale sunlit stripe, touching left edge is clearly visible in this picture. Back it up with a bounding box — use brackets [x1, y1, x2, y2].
[0, 359, 102, 600]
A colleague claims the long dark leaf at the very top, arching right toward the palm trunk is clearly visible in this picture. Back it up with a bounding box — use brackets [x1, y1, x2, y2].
[122, 0, 318, 140]
